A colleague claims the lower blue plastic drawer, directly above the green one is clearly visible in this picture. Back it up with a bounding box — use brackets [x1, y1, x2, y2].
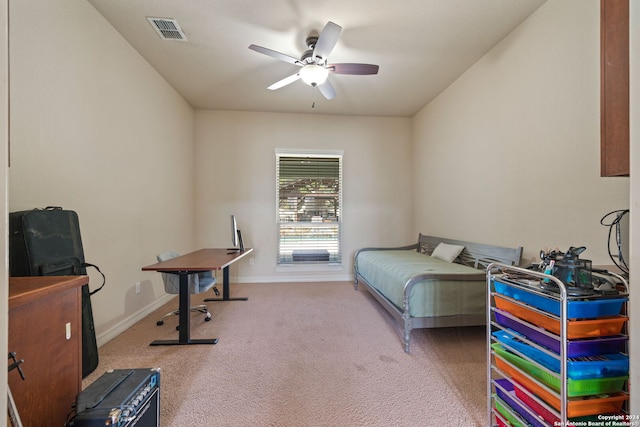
[493, 330, 629, 380]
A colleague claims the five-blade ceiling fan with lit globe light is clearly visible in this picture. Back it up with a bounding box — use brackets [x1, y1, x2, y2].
[249, 21, 379, 99]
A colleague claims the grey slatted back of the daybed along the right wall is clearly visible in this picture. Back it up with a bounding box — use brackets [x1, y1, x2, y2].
[418, 234, 522, 269]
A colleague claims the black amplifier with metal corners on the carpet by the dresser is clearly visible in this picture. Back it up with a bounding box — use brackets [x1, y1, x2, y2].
[68, 368, 160, 427]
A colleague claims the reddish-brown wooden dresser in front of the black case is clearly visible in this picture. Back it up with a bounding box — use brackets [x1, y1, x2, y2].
[8, 276, 89, 426]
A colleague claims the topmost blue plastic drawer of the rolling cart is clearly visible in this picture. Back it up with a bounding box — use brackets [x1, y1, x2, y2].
[493, 280, 627, 319]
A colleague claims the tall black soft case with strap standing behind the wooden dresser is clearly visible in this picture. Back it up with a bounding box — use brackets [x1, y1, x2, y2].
[9, 207, 105, 378]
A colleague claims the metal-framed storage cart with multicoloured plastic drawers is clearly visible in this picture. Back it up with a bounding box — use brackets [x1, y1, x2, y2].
[487, 263, 629, 427]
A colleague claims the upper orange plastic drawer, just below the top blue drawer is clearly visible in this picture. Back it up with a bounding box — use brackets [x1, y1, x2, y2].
[494, 295, 629, 340]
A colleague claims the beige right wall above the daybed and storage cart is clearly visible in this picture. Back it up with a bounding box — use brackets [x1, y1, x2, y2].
[414, 0, 629, 264]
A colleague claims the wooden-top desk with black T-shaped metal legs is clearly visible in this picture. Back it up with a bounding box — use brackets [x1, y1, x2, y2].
[142, 248, 253, 345]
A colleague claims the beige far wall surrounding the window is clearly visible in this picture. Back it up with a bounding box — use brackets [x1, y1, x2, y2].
[195, 111, 416, 282]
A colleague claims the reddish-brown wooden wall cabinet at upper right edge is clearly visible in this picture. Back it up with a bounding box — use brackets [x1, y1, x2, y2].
[600, 0, 629, 176]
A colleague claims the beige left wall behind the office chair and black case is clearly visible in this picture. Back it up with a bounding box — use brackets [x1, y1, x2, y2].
[9, 0, 194, 344]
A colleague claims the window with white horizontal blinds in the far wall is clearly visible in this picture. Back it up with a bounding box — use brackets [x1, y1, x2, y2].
[276, 151, 342, 265]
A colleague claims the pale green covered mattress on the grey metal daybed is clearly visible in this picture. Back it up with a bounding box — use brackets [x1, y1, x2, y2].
[356, 250, 486, 317]
